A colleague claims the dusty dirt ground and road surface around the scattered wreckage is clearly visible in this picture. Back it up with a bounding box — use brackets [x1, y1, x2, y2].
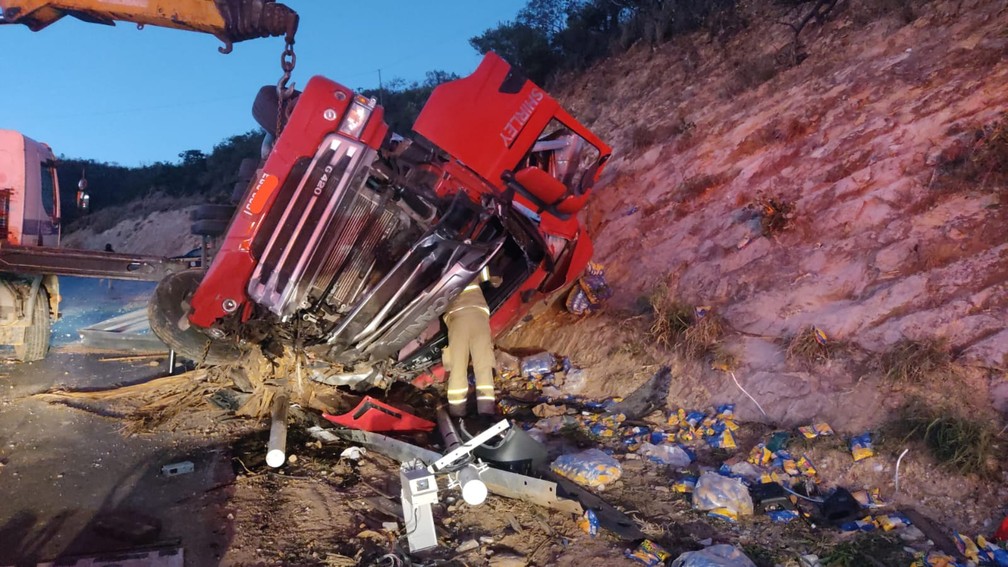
[0, 343, 1005, 566]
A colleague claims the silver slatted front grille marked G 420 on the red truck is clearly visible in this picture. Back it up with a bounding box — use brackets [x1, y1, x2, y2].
[248, 134, 397, 319]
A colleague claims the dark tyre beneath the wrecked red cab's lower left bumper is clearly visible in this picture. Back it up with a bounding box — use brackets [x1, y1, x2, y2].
[147, 269, 242, 364]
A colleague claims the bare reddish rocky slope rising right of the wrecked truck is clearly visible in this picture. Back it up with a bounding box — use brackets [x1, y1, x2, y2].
[504, 1, 1008, 429]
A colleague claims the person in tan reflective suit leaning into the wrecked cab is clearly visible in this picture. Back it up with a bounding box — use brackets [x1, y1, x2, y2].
[443, 268, 500, 418]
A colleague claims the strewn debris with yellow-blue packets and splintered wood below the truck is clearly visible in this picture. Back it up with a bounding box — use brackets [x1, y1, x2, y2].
[21, 338, 1004, 565]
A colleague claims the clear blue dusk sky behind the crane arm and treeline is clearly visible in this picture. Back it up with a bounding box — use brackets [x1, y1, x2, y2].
[0, 0, 525, 165]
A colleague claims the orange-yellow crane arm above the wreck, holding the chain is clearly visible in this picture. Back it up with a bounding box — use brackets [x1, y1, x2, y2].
[0, 0, 297, 53]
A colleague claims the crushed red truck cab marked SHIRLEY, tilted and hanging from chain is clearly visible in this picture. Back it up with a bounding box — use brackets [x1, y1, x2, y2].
[150, 53, 611, 385]
